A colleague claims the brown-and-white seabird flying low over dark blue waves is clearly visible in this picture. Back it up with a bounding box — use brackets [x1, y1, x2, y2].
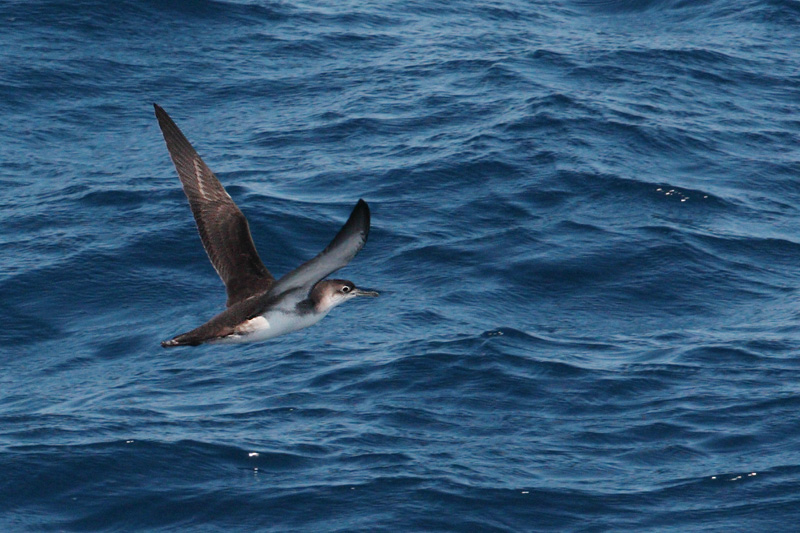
[153, 104, 378, 348]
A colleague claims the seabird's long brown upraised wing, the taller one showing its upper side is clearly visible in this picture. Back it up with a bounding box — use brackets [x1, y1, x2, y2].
[153, 104, 275, 307]
